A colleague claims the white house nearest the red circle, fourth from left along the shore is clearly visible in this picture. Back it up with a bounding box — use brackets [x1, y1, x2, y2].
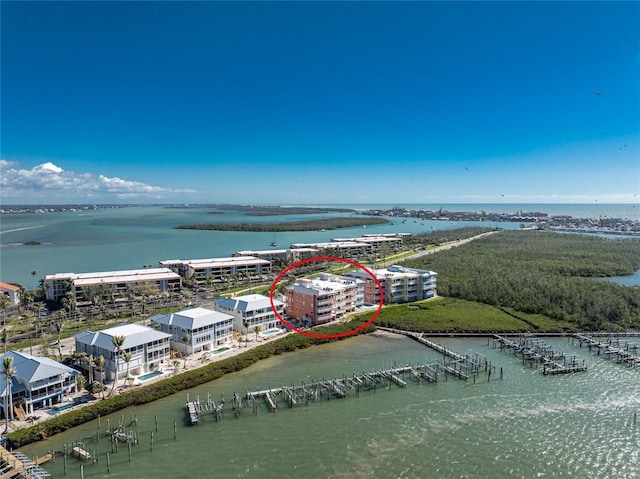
[214, 294, 284, 334]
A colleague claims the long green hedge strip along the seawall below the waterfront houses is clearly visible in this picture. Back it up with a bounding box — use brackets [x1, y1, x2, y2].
[7, 322, 375, 449]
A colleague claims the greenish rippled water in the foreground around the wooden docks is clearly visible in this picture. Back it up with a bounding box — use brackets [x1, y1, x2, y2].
[23, 333, 640, 479]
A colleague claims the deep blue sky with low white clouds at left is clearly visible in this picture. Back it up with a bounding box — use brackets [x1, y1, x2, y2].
[0, 1, 640, 204]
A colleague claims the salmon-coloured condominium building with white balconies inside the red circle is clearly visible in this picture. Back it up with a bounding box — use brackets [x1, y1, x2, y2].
[285, 274, 359, 325]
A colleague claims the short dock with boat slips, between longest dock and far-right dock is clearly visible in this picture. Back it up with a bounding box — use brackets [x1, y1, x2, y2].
[493, 334, 587, 375]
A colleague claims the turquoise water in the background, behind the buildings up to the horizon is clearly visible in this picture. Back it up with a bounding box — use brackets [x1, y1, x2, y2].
[0, 204, 638, 289]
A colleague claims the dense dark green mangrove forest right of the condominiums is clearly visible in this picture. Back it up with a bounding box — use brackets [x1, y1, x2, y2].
[404, 231, 640, 330]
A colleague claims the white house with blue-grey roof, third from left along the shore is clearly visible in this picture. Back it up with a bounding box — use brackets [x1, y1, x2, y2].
[151, 308, 233, 356]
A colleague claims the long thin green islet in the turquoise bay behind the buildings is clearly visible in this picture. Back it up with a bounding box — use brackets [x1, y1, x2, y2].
[176, 216, 388, 232]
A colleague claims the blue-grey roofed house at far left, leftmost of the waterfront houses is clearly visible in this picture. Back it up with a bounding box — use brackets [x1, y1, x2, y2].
[0, 351, 79, 418]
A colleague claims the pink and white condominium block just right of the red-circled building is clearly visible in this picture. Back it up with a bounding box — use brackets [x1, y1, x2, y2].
[345, 265, 437, 304]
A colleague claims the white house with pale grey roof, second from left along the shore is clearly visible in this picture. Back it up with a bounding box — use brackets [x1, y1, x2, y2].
[74, 324, 171, 382]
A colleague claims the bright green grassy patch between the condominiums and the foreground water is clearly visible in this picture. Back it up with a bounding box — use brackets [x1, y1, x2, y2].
[356, 298, 575, 332]
